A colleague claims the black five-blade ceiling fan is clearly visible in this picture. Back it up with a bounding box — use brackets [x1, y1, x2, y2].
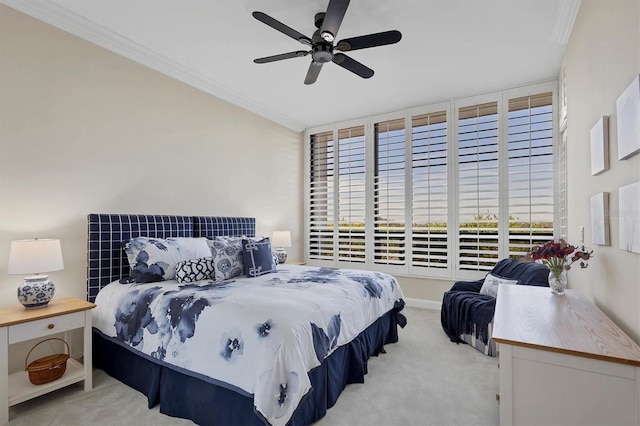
[252, 0, 402, 84]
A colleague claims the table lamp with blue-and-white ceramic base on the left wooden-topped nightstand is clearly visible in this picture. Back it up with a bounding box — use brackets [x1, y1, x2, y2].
[7, 238, 64, 309]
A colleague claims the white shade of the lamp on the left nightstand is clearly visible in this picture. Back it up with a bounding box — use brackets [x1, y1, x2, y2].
[7, 238, 64, 275]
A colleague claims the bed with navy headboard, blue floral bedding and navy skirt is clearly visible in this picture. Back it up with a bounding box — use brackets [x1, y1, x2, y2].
[87, 214, 406, 426]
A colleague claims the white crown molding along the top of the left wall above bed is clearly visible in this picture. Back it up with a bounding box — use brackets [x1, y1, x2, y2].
[0, 0, 306, 132]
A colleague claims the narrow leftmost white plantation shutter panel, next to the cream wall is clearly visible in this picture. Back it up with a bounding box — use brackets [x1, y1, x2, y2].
[309, 132, 335, 260]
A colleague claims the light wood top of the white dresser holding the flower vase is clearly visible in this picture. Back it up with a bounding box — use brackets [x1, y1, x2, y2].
[492, 285, 640, 366]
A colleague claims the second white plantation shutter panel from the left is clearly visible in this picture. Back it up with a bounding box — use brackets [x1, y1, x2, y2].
[338, 126, 366, 263]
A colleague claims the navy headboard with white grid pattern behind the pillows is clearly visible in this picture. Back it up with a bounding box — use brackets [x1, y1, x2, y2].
[87, 214, 256, 302]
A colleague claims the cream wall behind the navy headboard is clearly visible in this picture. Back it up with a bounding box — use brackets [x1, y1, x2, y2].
[0, 5, 303, 370]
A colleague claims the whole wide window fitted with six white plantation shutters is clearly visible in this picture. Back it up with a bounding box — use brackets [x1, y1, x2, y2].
[306, 82, 562, 278]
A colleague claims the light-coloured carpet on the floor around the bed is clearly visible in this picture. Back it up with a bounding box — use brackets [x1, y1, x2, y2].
[9, 308, 499, 426]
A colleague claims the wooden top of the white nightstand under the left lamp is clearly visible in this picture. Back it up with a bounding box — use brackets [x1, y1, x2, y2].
[0, 297, 96, 327]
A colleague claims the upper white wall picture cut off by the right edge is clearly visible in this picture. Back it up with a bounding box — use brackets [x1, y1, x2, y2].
[616, 74, 640, 160]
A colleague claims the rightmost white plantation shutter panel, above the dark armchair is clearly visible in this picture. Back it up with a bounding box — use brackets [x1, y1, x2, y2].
[507, 92, 554, 257]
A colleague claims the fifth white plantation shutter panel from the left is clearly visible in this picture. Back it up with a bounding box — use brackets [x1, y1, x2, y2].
[458, 102, 500, 271]
